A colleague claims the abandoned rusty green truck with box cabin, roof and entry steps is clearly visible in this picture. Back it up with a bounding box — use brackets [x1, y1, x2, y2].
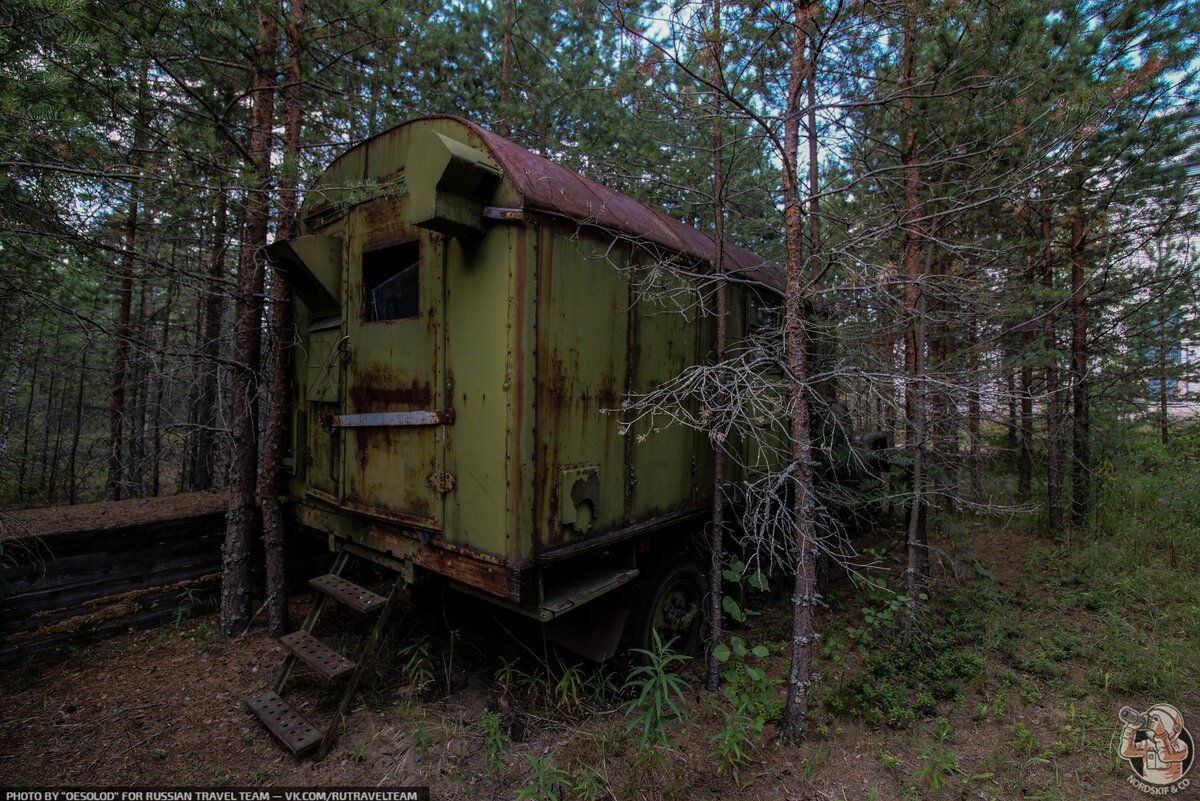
[248, 116, 816, 751]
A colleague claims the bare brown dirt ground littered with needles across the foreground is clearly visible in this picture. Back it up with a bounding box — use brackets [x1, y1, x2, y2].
[0, 525, 1161, 801]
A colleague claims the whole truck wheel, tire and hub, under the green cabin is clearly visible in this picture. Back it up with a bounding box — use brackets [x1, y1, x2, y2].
[623, 558, 704, 656]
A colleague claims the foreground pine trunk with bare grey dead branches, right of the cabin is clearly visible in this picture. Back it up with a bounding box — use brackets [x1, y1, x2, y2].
[779, 0, 817, 742]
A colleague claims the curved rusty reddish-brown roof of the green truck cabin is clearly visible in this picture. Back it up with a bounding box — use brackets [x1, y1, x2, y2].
[324, 114, 784, 294]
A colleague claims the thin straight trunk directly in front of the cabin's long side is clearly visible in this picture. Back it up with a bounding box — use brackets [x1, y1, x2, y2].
[706, 0, 728, 692]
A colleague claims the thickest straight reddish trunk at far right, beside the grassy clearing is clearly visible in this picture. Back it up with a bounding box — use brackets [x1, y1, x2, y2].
[1070, 194, 1092, 530]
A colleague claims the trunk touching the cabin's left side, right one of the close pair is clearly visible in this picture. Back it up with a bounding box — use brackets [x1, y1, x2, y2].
[259, 0, 305, 637]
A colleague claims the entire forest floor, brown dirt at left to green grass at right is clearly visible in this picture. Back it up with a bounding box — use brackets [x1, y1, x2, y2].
[0, 429, 1200, 801]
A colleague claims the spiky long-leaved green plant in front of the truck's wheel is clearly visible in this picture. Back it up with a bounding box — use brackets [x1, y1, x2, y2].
[624, 631, 688, 751]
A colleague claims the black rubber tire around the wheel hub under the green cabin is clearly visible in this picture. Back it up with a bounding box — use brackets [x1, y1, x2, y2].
[622, 553, 707, 661]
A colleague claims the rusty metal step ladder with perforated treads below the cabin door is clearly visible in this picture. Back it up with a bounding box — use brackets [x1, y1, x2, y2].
[245, 543, 404, 759]
